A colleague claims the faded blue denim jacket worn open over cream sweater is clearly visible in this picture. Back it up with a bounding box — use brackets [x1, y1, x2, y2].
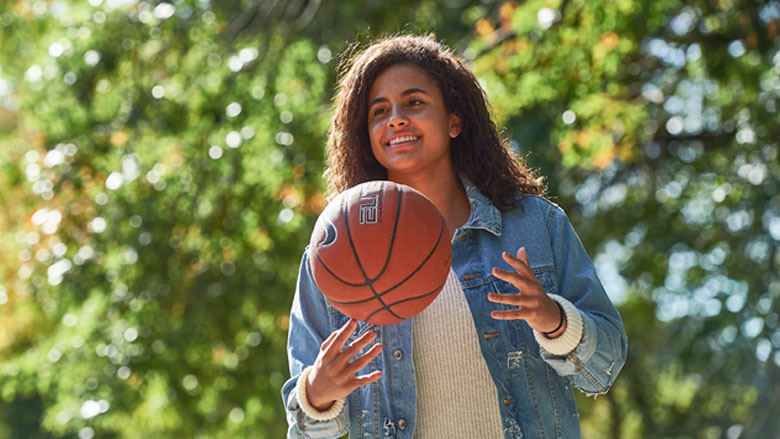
[282, 182, 627, 439]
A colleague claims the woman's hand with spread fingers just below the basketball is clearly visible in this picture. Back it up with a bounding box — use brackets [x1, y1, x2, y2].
[306, 319, 382, 411]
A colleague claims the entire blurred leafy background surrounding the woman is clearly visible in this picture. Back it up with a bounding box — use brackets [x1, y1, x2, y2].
[0, 0, 780, 439]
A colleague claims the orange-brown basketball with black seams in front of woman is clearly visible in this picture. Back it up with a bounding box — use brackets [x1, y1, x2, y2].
[308, 181, 452, 325]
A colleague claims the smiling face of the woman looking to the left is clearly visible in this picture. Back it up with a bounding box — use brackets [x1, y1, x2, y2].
[368, 63, 460, 181]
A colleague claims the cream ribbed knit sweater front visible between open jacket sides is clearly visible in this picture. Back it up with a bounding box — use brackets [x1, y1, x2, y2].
[412, 270, 504, 439]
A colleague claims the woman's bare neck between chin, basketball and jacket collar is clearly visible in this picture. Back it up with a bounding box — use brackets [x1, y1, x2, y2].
[388, 170, 471, 236]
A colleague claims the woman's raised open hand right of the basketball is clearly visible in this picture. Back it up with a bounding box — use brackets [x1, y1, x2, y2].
[488, 247, 566, 338]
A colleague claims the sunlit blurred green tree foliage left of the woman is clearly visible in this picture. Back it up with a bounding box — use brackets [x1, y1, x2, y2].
[0, 1, 332, 437]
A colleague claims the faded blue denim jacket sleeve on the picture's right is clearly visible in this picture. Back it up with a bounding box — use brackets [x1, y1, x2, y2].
[542, 205, 628, 394]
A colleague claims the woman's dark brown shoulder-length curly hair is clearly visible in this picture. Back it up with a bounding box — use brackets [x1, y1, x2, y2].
[325, 34, 545, 211]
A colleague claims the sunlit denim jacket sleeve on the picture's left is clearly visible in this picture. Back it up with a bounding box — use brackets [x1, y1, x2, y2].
[282, 252, 349, 439]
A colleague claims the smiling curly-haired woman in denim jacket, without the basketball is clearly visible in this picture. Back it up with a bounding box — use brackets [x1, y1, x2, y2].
[282, 36, 627, 439]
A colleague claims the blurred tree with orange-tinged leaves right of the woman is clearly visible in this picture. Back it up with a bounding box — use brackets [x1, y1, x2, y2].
[469, 0, 780, 438]
